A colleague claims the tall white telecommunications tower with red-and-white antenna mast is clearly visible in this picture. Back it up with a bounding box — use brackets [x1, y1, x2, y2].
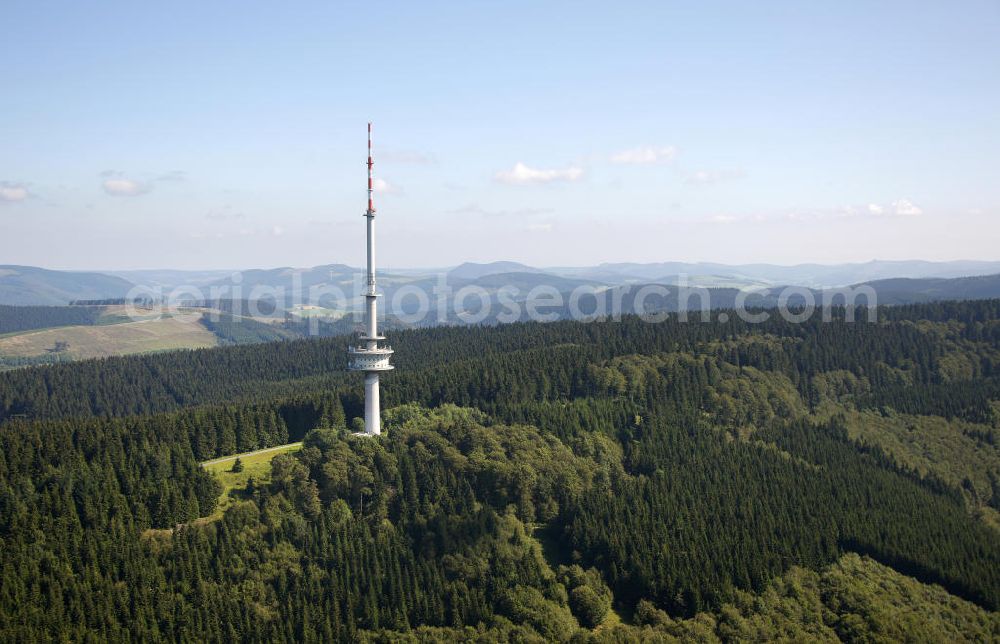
[347, 123, 393, 436]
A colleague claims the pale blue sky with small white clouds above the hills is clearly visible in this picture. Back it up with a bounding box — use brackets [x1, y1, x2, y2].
[0, 0, 1000, 269]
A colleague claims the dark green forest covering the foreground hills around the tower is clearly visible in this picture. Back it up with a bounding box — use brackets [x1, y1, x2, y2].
[0, 300, 1000, 642]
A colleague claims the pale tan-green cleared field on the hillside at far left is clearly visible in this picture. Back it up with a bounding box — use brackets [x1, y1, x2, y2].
[0, 317, 219, 360]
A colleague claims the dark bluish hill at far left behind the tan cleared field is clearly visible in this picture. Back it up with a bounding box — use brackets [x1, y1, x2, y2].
[0, 266, 133, 305]
